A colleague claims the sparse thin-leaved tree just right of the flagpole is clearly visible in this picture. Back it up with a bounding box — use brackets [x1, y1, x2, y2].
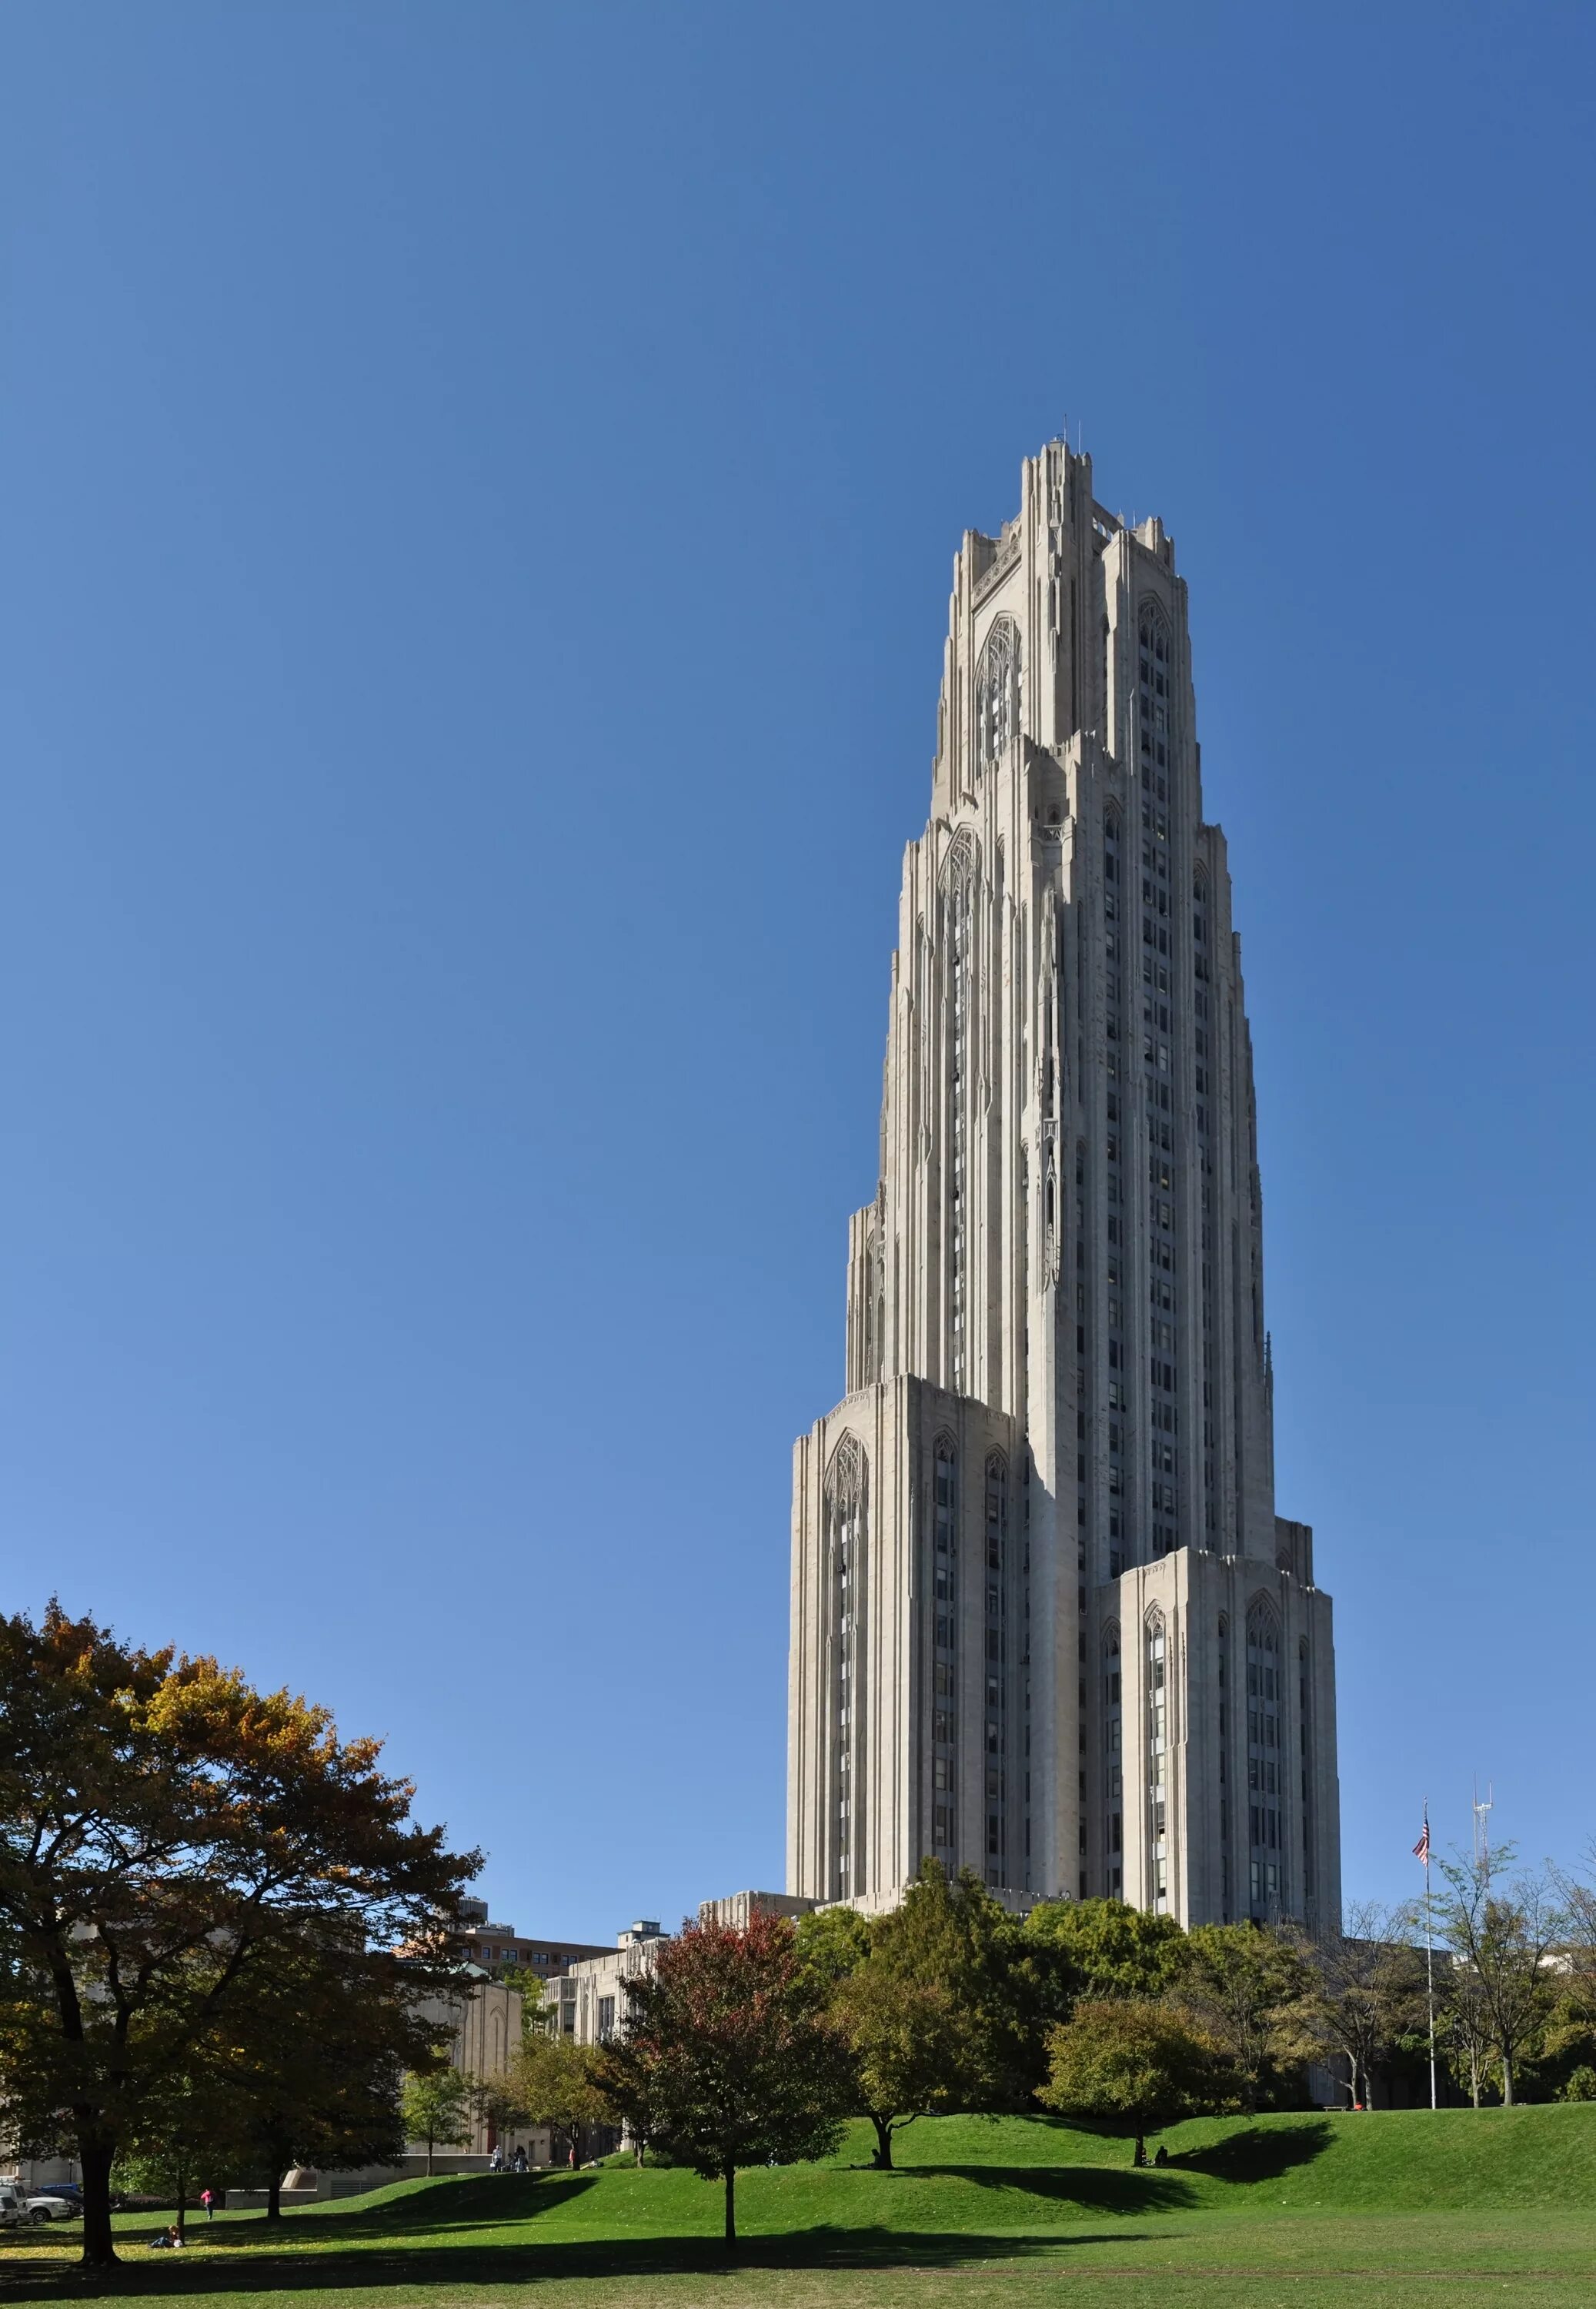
[1434, 1845, 1571, 2108]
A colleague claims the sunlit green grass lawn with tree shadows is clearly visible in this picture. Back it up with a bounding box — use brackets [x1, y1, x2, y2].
[0, 2106, 1596, 2309]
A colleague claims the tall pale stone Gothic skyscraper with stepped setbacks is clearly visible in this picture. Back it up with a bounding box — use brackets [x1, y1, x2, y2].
[787, 441, 1340, 1923]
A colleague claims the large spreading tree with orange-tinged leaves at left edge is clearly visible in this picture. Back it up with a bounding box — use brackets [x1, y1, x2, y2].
[0, 1605, 478, 2267]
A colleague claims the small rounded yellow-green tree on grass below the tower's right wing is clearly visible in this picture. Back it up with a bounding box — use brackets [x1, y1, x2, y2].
[1037, 1997, 1240, 2166]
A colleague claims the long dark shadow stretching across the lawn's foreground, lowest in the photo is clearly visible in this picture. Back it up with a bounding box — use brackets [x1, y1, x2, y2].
[0, 2228, 1154, 2302]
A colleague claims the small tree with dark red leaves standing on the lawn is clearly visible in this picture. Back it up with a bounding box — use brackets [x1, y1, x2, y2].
[598, 1910, 853, 2244]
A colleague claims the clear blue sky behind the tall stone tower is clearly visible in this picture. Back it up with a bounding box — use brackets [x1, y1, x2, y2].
[0, 0, 1596, 1940]
